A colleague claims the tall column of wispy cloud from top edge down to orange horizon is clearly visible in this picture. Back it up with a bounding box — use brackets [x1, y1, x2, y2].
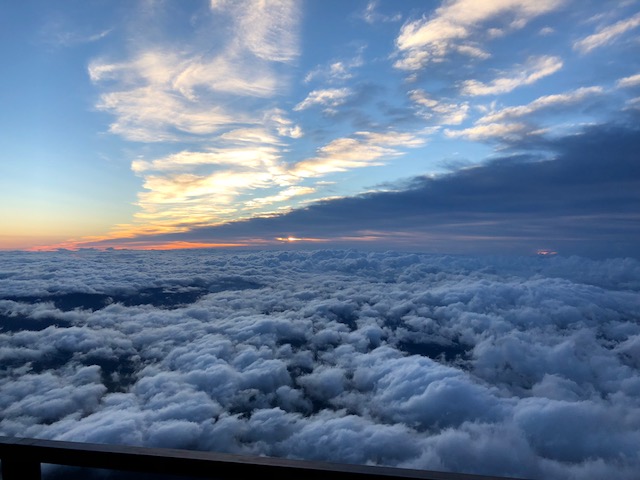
[88, 0, 303, 235]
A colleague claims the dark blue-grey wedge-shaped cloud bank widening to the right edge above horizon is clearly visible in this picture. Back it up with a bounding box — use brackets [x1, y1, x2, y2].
[89, 114, 640, 258]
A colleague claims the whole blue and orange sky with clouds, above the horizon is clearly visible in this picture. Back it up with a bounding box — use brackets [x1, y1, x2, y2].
[0, 0, 640, 257]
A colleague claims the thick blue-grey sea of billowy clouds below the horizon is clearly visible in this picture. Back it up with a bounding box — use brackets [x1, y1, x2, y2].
[0, 250, 640, 479]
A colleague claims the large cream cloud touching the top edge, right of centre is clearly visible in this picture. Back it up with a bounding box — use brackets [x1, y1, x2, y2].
[394, 0, 564, 71]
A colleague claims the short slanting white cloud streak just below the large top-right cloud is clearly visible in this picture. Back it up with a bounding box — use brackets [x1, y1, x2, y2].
[461, 56, 563, 96]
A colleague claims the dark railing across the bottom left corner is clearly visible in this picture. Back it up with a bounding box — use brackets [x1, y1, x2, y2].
[0, 437, 524, 480]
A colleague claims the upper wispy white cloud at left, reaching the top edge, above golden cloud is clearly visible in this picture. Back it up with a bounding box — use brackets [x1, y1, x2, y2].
[88, 0, 300, 142]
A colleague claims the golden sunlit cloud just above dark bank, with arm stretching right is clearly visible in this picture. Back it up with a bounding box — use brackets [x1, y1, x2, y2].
[112, 125, 434, 244]
